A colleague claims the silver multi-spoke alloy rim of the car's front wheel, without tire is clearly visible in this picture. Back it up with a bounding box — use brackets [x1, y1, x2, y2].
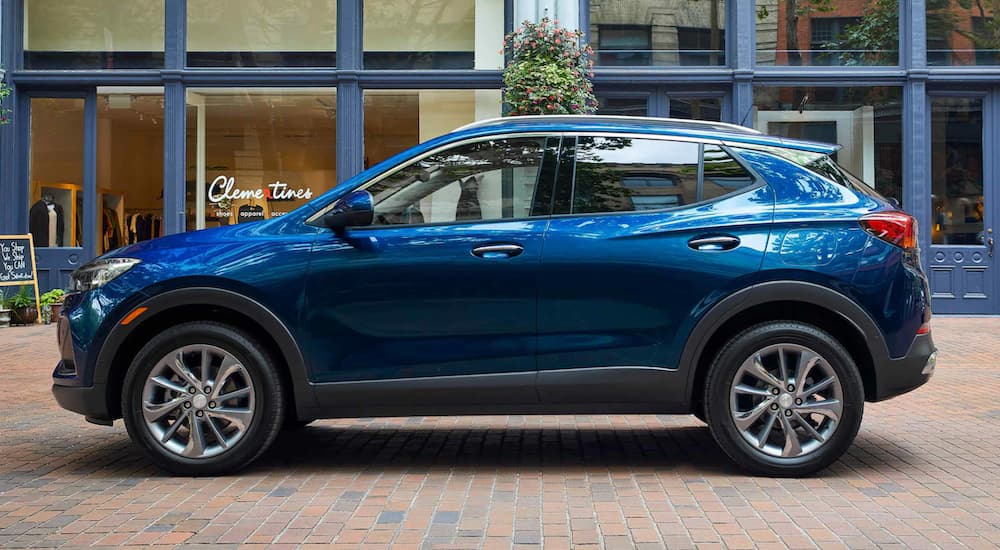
[142, 344, 255, 459]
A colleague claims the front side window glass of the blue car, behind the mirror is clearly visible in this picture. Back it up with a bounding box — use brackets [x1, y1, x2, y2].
[367, 137, 555, 225]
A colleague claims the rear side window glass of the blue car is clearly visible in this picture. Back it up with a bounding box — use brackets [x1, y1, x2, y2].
[572, 136, 753, 214]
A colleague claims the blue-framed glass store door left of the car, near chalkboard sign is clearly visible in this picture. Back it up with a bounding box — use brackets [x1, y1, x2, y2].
[19, 91, 95, 291]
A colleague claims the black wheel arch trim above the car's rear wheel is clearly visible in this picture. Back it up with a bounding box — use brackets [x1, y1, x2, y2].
[680, 281, 892, 403]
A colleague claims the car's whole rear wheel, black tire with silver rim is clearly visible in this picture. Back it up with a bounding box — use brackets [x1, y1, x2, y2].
[705, 322, 864, 476]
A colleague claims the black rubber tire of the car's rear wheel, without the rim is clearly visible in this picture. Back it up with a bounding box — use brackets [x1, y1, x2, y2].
[704, 321, 864, 477]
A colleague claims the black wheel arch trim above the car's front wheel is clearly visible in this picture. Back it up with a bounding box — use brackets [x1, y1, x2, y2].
[94, 287, 316, 413]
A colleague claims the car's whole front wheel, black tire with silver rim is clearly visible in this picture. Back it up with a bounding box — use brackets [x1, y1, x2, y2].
[122, 322, 286, 475]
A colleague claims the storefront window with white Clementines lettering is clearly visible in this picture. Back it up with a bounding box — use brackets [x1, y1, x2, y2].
[186, 88, 337, 230]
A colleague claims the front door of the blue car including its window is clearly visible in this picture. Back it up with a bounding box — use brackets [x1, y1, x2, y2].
[304, 136, 559, 405]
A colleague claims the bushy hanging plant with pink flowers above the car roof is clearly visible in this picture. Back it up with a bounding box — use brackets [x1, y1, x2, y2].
[503, 17, 597, 115]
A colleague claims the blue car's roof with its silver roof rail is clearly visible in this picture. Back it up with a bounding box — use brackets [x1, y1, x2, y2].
[454, 115, 840, 154]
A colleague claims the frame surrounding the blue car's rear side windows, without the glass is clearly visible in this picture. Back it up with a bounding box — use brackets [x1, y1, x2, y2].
[550, 131, 767, 218]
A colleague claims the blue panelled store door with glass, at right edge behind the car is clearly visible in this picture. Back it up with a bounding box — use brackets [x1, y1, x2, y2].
[921, 92, 1000, 314]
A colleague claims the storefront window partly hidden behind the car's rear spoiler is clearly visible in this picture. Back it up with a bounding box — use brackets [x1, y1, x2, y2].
[753, 86, 903, 204]
